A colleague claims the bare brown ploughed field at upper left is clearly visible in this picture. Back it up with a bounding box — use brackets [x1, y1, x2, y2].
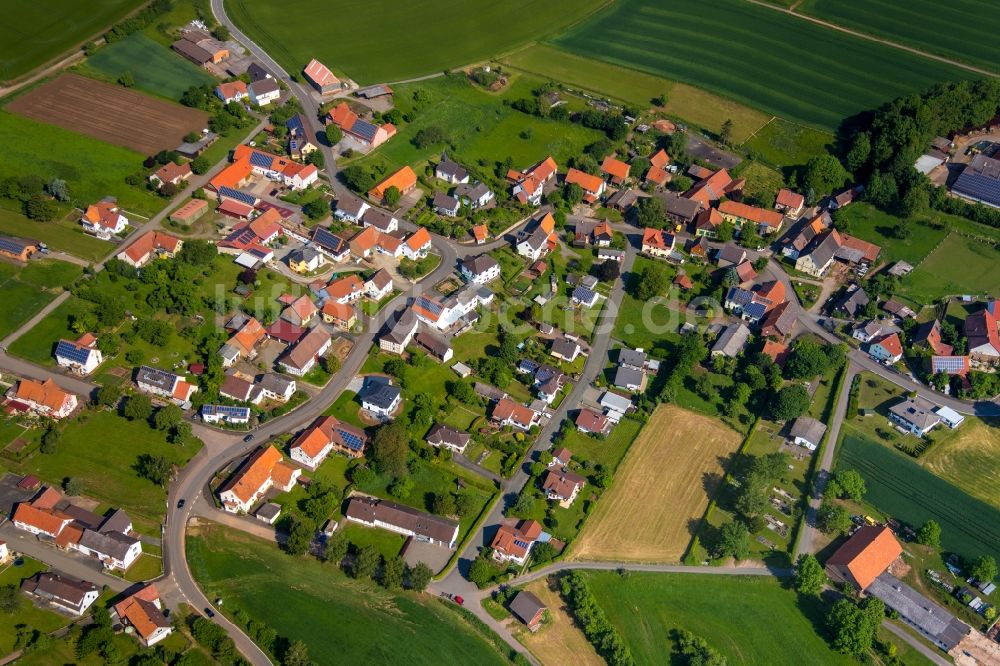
[6, 74, 208, 155]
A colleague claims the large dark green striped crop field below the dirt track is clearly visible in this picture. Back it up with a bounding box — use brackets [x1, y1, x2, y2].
[553, 0, 973, 130]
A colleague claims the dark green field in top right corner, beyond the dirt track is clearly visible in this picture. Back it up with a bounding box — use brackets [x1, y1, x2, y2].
[796, 0, 1000, 71]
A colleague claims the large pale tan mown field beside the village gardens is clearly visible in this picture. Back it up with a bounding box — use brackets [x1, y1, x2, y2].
[569, 405, 741, 563]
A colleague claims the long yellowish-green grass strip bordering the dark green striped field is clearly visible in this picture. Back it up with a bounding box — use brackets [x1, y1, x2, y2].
[502, 44, 768, 142]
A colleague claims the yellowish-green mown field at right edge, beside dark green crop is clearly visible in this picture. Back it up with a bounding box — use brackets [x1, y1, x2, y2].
[919, 417, 1000, 508]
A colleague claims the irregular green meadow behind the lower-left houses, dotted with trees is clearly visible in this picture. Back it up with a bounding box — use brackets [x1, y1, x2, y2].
[10, 411, 201, 536]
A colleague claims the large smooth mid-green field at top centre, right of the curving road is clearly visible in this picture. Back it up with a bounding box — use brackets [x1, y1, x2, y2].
[226, 0, 605, 84]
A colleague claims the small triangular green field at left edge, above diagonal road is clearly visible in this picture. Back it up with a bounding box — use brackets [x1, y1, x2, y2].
[0, 260, 83, 338]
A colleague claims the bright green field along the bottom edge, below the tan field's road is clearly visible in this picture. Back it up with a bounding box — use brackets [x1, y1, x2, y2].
[586, 572, 856, 666]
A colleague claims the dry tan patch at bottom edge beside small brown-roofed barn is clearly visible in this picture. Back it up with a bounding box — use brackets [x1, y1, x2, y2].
[517, 578, 605, 666]
